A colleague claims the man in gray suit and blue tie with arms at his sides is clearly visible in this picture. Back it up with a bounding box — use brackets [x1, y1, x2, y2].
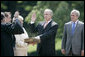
[61, 9, 84, 56]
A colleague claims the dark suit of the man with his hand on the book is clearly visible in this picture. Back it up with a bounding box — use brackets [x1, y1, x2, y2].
[31, 21, 58, 56]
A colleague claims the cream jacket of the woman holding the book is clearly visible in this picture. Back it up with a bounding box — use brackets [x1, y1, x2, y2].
[15, 28, 29, 47]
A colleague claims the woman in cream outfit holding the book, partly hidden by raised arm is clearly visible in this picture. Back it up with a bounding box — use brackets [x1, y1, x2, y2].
[13, 11, 29, 56]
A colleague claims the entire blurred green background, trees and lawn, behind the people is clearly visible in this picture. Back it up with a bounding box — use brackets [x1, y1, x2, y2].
[1, 1, 84, 56]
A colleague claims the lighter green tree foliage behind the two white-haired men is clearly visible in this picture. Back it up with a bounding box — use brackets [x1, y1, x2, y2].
[25, 1, 84, 38]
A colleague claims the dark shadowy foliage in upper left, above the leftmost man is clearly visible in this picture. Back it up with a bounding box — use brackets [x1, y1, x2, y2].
[1, 1, 37, 18]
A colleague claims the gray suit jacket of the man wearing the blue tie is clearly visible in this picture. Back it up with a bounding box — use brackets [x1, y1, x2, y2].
[62, 20, 84, 55]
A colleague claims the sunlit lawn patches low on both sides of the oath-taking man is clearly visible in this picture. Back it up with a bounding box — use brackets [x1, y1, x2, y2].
[28, 38, 63, 56]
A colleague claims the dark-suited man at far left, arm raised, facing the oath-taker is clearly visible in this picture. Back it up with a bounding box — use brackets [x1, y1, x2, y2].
[1, 13, 23, 56]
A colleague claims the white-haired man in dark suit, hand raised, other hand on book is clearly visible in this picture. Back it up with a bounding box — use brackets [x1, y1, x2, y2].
[30, 9, 58, 56]
